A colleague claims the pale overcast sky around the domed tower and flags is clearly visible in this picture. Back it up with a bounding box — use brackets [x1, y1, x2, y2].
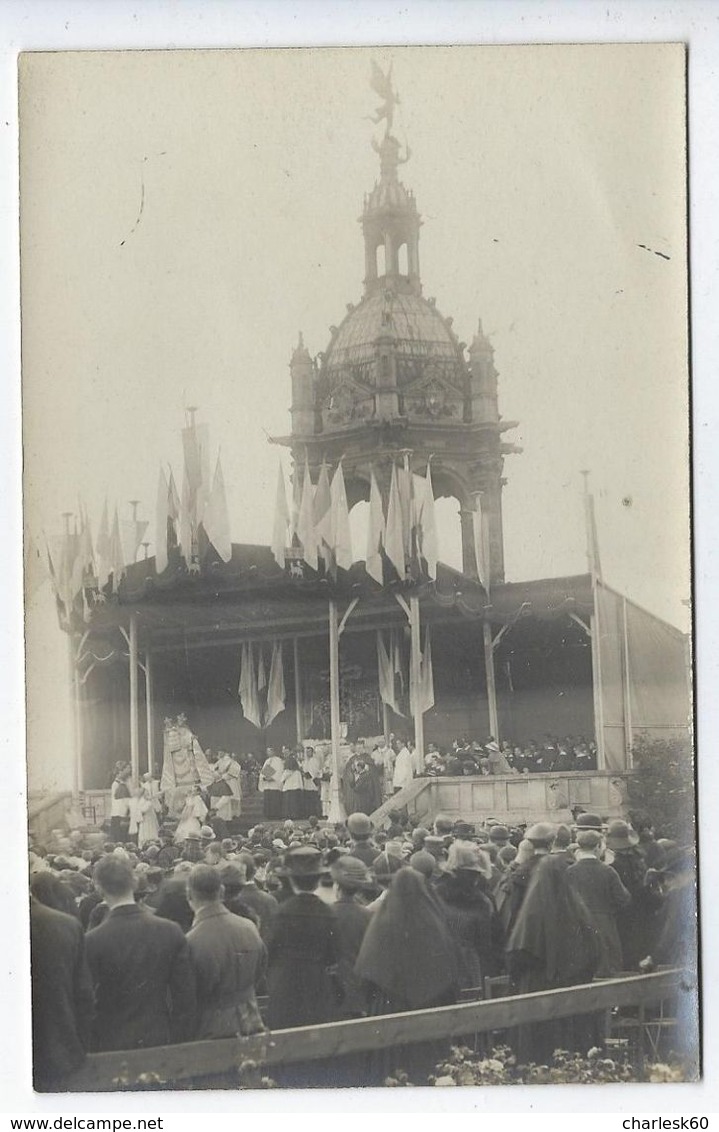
[20, 44, 690, 783]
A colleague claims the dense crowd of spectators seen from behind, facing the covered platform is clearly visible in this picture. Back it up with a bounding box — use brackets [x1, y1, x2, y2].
[29, 790, 695, 1090]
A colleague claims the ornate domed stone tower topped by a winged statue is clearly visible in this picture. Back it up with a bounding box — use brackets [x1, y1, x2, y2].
[271, 70, 519, 584]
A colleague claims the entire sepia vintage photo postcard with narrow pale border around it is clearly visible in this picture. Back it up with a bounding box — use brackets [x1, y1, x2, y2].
[19, 43, 701, 1092]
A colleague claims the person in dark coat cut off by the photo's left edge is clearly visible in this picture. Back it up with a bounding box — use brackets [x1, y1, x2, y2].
[29, 899, 94, 1092]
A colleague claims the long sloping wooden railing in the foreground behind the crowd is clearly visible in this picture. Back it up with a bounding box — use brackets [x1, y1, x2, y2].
[63, 969, 696, 1092]
